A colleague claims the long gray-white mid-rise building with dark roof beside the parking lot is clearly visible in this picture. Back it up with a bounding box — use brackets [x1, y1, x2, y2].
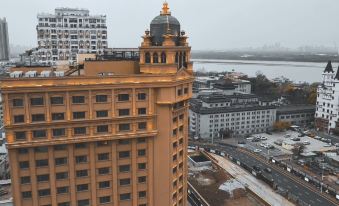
[190, 94, 276, 138]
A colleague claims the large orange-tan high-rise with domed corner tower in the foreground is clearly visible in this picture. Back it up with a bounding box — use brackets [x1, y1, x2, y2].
[0, 3, 193, 206]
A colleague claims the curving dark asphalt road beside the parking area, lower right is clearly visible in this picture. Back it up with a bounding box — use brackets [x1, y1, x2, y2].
[193, 142, 339, 206]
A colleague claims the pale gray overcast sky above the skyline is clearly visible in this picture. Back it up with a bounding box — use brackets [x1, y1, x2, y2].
[0, 0, 339, 50]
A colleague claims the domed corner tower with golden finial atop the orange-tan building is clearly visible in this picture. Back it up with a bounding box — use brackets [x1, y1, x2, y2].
[139, 2, 192, 74]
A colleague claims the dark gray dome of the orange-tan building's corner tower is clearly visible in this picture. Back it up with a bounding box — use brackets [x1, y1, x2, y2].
[150, 14, 180, 46]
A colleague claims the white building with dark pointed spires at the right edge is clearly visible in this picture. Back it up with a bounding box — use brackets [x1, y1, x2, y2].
[315, 61, 339, 132]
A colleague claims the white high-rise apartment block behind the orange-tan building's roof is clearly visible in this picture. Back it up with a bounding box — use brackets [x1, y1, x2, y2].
[33, 8, 107, 65]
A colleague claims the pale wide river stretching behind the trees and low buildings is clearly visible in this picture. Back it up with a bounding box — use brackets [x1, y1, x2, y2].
[193, 59, 337, 83]
